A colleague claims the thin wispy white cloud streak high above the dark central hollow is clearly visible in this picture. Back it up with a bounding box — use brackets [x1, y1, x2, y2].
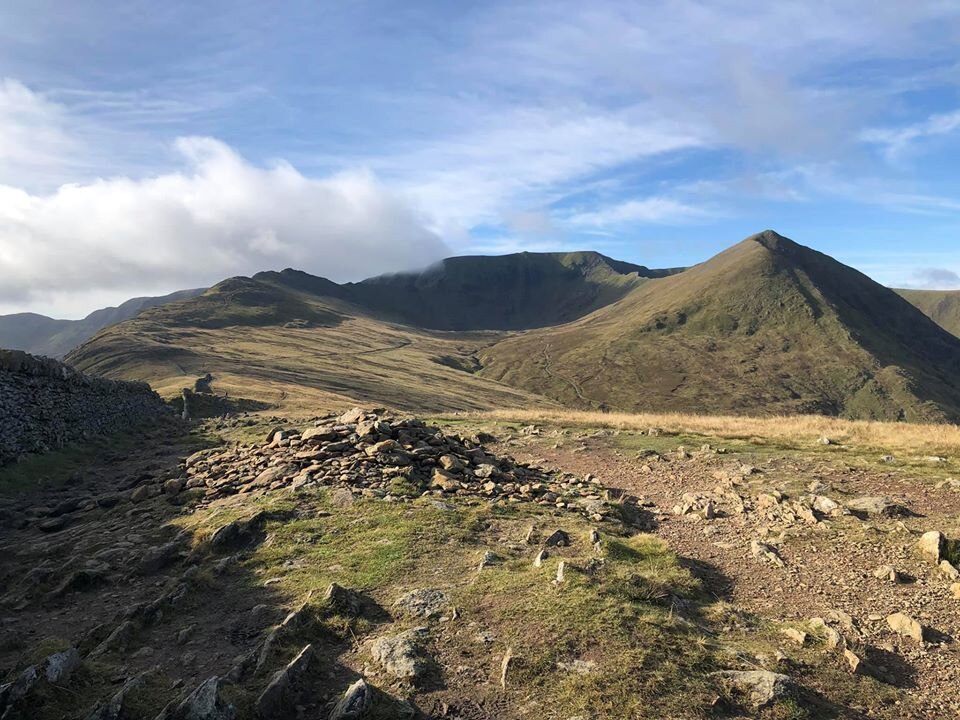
[370, 107, 702, 227]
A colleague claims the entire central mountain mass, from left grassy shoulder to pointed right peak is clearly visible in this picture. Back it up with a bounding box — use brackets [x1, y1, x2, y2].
[62, 231, 960, 422]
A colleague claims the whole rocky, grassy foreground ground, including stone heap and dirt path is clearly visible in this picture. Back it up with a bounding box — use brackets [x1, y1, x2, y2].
[0, 410, 960, 720]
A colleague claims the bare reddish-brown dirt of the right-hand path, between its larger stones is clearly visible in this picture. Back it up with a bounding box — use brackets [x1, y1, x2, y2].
[511, 437, 960, 718]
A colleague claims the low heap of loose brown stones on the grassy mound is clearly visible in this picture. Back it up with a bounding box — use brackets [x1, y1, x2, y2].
[176, 408, 611, 520]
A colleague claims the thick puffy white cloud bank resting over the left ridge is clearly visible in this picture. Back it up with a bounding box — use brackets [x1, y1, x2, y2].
[0, 138, 447, 309]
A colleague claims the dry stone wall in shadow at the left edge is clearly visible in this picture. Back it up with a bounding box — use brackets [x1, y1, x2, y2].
[0, 350, 171, 466]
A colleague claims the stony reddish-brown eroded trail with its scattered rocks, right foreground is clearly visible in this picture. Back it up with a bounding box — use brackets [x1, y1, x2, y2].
[502, 428, 960, 718]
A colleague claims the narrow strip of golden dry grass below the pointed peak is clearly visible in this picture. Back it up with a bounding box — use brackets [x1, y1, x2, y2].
[456, 409, 960, 453]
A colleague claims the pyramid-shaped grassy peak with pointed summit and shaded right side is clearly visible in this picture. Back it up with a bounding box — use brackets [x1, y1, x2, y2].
[481, 231, 960, 420]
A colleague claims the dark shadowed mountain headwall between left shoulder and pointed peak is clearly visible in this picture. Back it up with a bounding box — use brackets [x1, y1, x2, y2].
[254, 252, 677, 330]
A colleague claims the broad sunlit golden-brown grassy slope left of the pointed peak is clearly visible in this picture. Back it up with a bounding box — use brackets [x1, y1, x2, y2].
[67, 276, 550, 414]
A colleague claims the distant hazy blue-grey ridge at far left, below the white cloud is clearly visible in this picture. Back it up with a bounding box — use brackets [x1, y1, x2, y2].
[0, 289, 203, 358]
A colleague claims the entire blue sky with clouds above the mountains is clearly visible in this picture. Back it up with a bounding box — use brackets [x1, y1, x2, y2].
[0, 0, 960, 318]
